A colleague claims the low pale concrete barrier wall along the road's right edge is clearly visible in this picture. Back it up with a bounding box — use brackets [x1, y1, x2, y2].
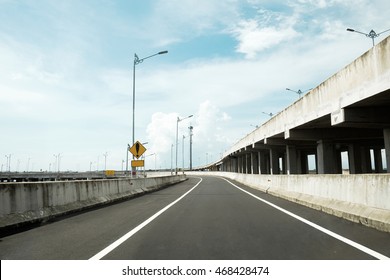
[187, 172, 390, 232]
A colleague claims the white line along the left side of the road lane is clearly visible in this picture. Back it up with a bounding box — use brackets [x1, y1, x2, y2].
[90, 177, 203, 260]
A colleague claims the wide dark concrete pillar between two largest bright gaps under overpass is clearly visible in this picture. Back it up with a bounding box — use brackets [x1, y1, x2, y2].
[317, 140, 340, 174]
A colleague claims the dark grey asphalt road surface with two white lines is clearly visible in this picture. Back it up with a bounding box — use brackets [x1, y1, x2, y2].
[0, 176, 390, 260]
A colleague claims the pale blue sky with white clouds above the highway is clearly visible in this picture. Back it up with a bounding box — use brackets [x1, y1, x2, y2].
[0, 0, 390, 172]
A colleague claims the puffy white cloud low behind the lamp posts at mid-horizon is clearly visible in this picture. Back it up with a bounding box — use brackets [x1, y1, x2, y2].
[147, 100, 231, 167]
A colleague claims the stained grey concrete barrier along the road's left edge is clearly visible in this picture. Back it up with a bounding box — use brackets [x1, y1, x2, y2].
[0, 175, 186, 230]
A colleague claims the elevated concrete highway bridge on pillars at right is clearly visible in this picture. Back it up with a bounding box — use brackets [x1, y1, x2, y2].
[209, 37, 390, 174]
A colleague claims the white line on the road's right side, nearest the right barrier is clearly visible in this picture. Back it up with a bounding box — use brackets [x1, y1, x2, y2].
[222, 178, 390, 260]
